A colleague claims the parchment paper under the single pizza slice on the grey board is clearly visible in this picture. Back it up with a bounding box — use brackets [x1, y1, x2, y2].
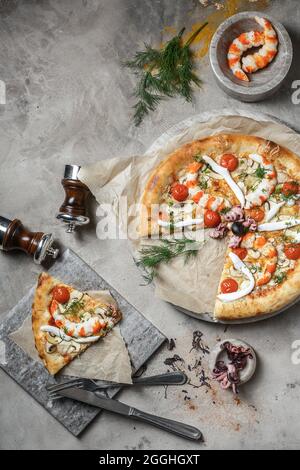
[9, 291, 132, 384]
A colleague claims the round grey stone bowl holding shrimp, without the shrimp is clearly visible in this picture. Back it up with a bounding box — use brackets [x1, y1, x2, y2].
[209, 11, 293, 102]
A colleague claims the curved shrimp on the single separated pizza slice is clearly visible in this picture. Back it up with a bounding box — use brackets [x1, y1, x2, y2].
[51, 300, 108, 338]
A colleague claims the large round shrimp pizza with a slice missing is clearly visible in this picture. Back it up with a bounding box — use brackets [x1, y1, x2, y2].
[139, 134, 300, 320]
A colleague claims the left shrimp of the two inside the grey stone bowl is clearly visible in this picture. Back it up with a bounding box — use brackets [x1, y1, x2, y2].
[227, 31, 265, 82]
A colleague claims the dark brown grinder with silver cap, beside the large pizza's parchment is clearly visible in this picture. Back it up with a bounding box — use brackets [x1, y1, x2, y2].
[56, 165, 90, 233]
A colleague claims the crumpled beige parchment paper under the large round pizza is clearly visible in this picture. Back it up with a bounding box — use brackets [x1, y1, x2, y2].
[79, 110, 300, 314]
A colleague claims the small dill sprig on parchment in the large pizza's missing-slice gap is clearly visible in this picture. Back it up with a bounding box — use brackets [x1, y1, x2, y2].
[136, 237, 200, 284]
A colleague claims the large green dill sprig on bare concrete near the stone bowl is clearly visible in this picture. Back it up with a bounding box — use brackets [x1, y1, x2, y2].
[125, 23, 208, 126]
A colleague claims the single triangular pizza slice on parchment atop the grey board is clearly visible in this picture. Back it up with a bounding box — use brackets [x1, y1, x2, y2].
[32, 273, 122, 375]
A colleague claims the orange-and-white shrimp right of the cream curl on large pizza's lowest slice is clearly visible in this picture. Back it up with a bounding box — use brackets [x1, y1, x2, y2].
[241, 232, 278, 286]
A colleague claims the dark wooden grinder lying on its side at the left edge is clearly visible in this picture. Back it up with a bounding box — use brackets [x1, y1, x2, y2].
[0, 216, 59, 264]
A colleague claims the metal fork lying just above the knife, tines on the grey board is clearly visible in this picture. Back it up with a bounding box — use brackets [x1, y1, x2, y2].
[46, 371, 187, 396]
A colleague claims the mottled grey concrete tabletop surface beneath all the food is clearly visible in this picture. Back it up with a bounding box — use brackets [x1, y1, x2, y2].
[0, 0, 300, 449]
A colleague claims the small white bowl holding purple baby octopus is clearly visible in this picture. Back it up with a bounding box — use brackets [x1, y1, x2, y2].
[209, 338, 256, 385]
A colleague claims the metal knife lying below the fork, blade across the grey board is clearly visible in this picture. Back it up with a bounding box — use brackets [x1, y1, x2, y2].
[57, 388, 202, 441]
